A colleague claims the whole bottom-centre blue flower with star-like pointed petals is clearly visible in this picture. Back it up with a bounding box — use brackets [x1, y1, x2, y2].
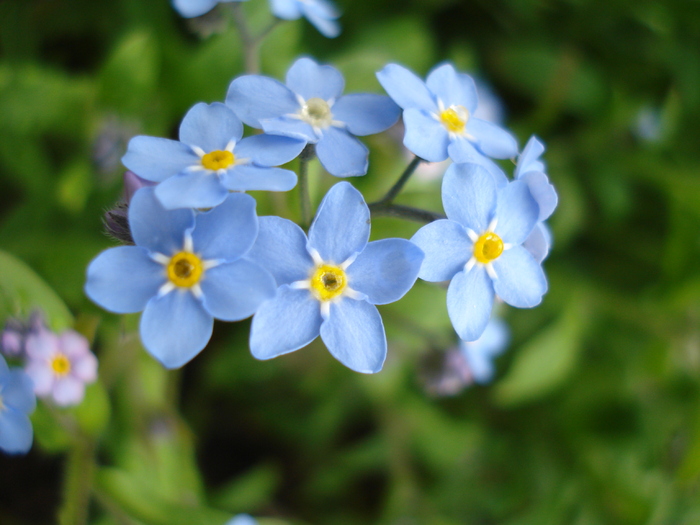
[249, 182, 423, 373]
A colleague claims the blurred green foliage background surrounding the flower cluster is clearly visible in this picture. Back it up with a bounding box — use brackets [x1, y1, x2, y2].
[0, 0, 700, 525]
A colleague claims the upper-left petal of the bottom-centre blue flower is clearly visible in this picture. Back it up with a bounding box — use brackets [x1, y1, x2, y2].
[246, 216, 314, 285]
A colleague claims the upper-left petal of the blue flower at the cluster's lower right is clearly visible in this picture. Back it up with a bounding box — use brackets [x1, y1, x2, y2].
[442, 163, 496, 234]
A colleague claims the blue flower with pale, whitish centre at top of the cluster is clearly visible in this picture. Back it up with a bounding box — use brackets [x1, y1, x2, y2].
[226, 58, 400, 177]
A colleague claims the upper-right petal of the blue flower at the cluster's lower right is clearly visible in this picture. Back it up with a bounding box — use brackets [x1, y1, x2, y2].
[495, 180, 540, 244]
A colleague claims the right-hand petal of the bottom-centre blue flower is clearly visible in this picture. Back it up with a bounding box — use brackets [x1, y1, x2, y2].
[347, 239, 423, 304]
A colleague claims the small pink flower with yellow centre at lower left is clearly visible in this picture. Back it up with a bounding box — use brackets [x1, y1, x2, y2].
[26, 330, 97, 406]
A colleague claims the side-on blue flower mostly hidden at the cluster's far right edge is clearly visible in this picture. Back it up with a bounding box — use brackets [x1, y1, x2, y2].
[515, 136, 558, 262]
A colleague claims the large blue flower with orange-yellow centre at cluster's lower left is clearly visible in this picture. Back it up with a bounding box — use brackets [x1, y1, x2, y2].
[85, 188, 275, 368]
